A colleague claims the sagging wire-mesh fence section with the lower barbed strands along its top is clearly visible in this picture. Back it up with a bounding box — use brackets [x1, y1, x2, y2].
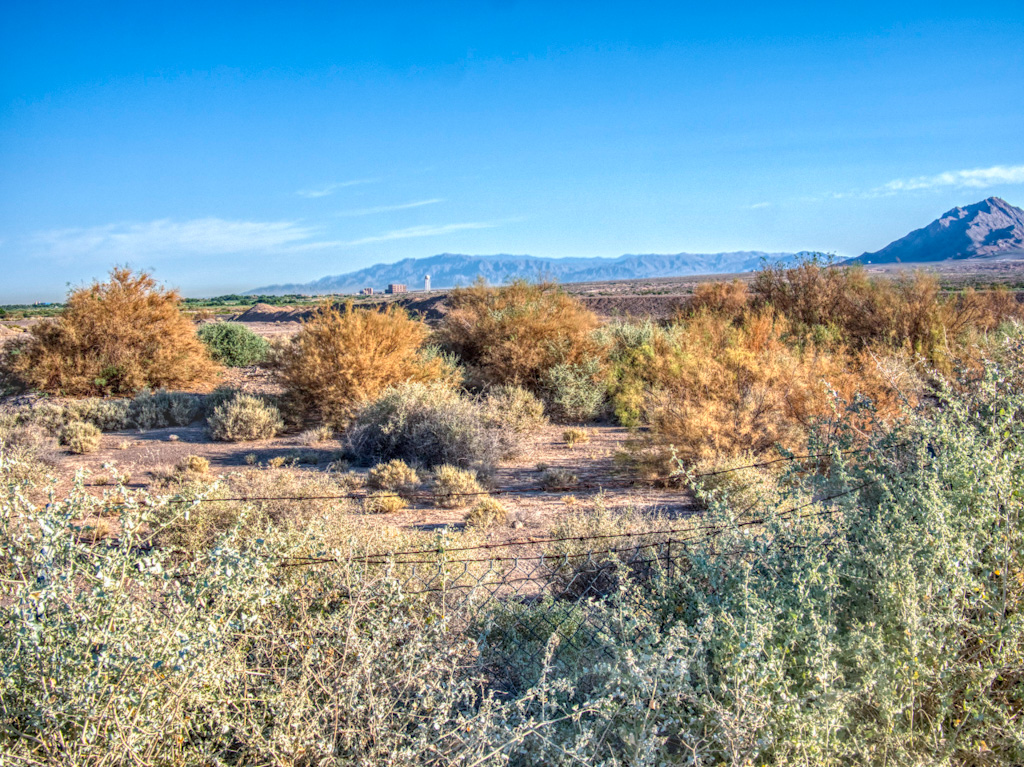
[335, 480, 879, 691]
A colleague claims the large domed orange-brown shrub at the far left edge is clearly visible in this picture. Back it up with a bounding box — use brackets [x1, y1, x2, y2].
[4, 268, 218, 395]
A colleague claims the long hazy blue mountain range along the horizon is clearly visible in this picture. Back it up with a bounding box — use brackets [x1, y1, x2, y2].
[247, 251, 800, 295]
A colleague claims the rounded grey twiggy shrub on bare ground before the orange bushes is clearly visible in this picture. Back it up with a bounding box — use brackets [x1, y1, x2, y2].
[345, 383, 514, 469]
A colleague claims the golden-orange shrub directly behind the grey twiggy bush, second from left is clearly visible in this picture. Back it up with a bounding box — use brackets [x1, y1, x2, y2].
[278, 302, 444, 427]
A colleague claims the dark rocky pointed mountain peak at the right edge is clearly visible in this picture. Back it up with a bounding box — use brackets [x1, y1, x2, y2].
[848, 197, 1024, 263]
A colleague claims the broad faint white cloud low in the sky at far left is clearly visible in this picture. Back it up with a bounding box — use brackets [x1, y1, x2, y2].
[26, 218, 329, 261]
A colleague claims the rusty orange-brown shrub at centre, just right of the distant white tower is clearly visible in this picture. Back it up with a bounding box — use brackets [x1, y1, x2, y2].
[437, 281, 599, 391]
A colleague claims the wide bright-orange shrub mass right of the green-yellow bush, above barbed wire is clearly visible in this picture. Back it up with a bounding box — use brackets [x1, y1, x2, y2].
[647, 309, 918, 468]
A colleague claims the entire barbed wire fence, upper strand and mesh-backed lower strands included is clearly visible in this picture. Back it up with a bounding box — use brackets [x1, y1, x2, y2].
[77, 436, 906, 691]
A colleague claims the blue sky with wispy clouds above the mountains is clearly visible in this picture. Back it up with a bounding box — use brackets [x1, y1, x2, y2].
[0, 1, 1024, 302]
